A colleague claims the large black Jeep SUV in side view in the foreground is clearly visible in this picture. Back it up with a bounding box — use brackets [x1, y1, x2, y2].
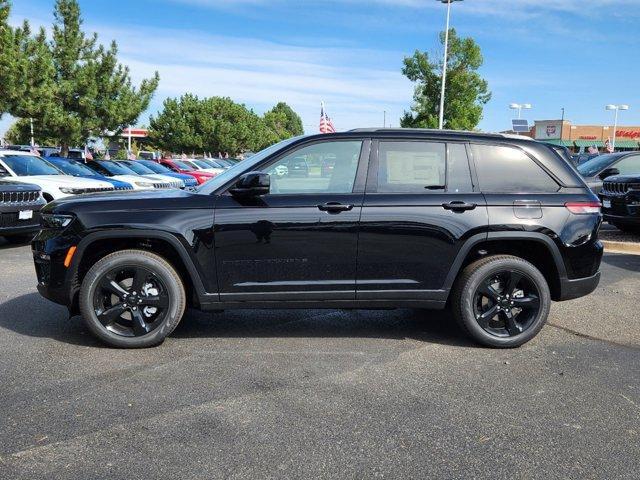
[33, 129, 602, 347]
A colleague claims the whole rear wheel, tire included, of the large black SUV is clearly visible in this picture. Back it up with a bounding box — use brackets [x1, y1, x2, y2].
[451, 255, 551, 348]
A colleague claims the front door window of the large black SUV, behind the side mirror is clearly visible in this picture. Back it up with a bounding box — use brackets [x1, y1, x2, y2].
[262, 140, 362, 194]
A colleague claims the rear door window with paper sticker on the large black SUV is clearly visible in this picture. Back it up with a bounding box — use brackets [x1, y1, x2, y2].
[377, 142, 446, 193]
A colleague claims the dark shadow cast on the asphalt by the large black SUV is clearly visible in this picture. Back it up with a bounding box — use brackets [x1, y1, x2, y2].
[0, 293, 475, 348]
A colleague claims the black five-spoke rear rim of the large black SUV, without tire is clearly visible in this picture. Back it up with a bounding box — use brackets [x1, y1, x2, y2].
[473, 270, 540, 337]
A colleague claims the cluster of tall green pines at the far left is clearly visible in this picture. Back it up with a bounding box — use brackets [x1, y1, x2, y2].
[0, 0, 159, 154]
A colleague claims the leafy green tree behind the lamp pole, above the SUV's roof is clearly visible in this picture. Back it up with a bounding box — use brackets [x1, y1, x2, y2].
[400, 29, 491, 130]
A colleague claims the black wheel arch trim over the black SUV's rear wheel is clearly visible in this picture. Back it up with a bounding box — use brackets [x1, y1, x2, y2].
[444, 232, 567, 300]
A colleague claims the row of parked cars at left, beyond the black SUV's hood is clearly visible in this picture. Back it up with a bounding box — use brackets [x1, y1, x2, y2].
[0, 150, 240, 243]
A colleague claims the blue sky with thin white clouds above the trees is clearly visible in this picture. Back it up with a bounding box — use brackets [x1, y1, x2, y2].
[0, 0, 640, 138]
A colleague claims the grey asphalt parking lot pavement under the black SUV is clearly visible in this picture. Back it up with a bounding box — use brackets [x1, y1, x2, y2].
[0, 240, 640, 480]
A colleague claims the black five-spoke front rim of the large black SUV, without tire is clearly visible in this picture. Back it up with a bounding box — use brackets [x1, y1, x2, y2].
[93, 265, 170, 337]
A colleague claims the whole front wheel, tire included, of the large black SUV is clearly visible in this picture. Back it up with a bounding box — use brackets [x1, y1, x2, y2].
[79, 250, 186, 348]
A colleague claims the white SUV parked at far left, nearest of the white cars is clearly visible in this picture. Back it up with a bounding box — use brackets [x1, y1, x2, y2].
[0, 150, 114, 202]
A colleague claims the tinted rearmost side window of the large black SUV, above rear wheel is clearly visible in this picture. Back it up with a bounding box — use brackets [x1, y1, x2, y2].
[471, 145, 559, 193]
